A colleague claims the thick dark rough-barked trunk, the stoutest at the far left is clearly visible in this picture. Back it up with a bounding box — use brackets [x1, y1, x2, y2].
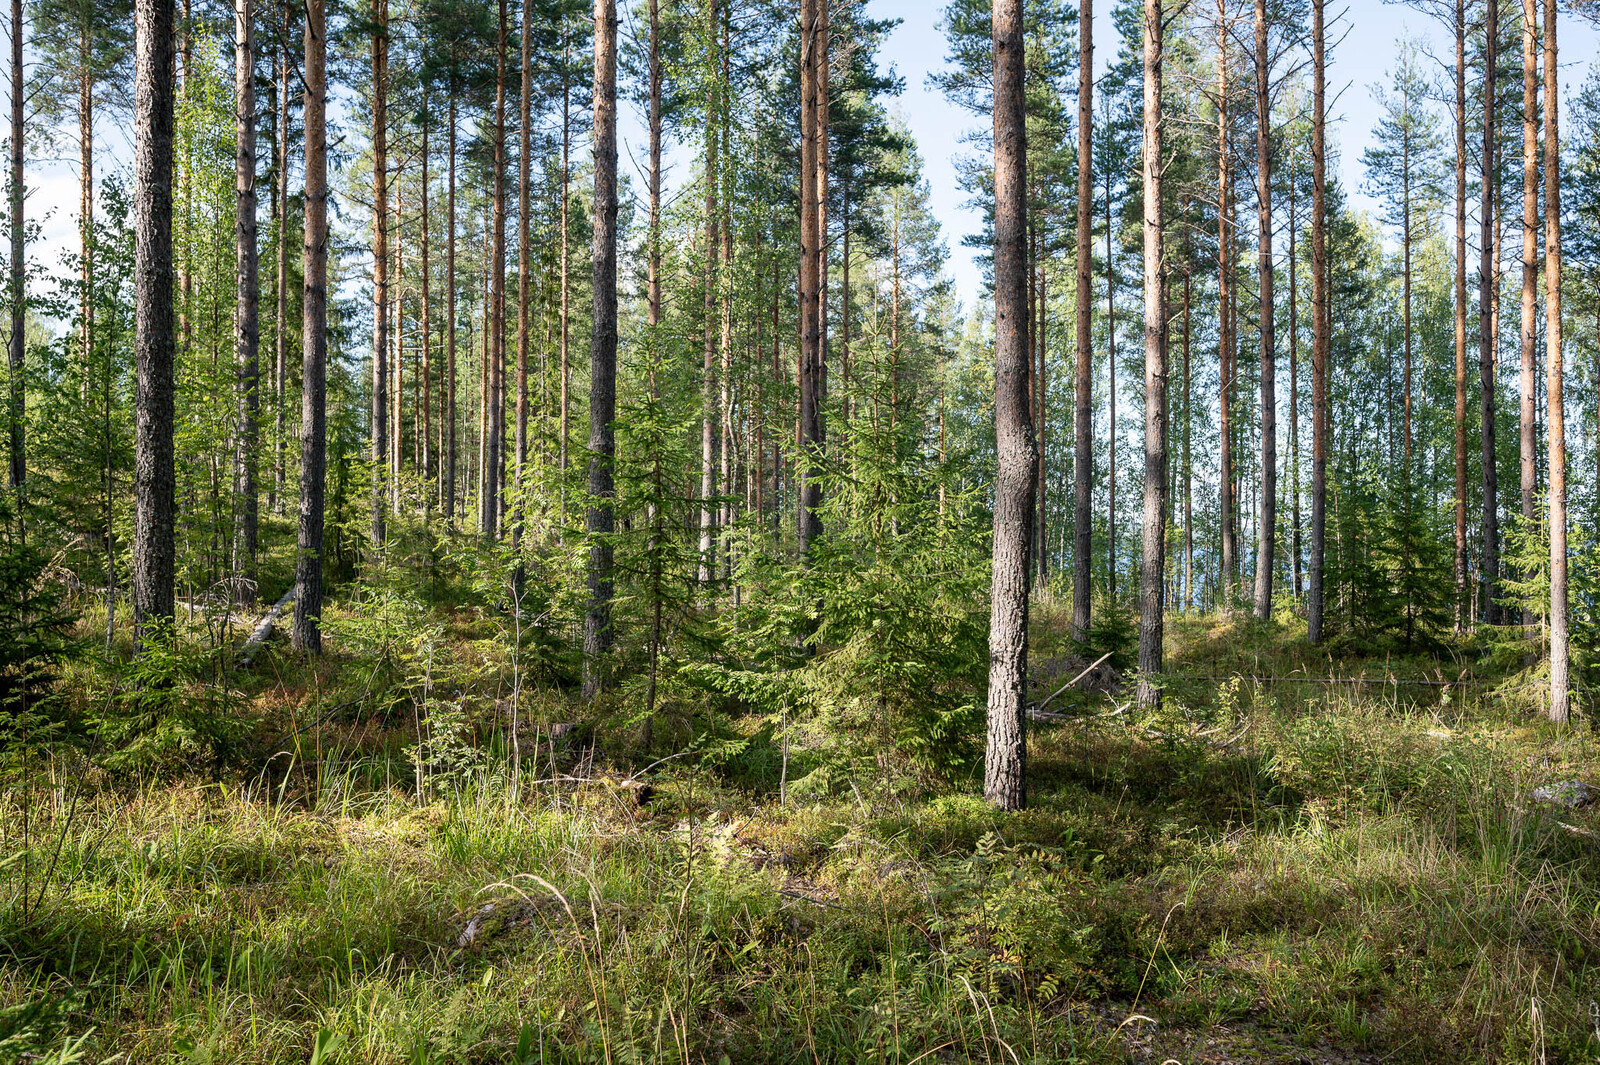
[133, 0, 176, 641]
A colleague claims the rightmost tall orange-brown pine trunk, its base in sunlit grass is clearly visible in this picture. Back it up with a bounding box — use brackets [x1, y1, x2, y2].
[1544, 0, 1571, 723]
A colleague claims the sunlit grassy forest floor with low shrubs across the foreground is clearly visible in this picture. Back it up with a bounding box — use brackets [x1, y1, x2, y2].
[0, 527, 1600, 1065]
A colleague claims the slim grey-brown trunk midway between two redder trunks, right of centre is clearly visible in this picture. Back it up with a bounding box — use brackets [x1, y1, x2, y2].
[1248, 0, 1273, 620]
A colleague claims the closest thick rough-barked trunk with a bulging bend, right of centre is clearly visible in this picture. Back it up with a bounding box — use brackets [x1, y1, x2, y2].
[984, 0, 1034, 809]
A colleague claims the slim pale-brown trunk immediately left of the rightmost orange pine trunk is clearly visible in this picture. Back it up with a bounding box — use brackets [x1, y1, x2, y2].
[1517, 0, 1539, 524]
